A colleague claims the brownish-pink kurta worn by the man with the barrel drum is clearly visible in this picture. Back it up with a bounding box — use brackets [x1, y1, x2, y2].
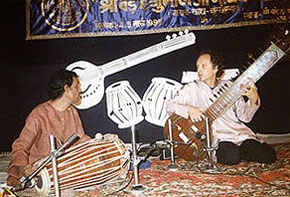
[8, 101, 91, 184]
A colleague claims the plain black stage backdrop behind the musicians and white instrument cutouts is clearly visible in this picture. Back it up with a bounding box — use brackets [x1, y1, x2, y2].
[0, 0, 290, 151]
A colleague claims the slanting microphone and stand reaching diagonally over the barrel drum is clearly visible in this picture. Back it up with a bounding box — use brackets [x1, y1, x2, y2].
[14, 134, 79, 191]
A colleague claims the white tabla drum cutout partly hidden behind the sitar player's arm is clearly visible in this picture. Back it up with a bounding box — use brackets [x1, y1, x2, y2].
[142, 77, 182, 127]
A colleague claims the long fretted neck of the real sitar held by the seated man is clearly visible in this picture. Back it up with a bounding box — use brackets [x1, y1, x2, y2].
[205, 43, 285, 121]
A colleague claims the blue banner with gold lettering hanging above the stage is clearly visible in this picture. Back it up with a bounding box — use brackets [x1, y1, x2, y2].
[26, 0, 290, 39]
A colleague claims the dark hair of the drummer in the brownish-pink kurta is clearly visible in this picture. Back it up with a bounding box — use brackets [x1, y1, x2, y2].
[48, 69, 78, 100]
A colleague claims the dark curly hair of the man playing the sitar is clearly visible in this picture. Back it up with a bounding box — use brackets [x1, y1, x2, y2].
[197, 50, 225, 78]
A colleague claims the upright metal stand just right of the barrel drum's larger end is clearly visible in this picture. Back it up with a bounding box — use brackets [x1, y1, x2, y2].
[131, 125, 145, 191]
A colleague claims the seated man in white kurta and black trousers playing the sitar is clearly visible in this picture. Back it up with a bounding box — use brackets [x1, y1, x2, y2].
[167, 50, 277, 165]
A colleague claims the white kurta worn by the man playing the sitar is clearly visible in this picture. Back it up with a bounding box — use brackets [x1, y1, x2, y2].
[166, 80, 260, 146]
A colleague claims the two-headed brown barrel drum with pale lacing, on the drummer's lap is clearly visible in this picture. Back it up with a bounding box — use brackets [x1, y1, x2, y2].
[35, 134, 129, 196]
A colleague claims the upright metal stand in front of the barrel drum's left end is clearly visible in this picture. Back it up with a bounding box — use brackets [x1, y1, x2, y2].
[49, 135, 60, 197]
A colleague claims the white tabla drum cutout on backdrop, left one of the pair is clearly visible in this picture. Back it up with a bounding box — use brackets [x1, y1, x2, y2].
[106, 81, 144, 129]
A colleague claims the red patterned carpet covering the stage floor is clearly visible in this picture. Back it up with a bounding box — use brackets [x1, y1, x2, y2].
[3, 144, 290, 197]
